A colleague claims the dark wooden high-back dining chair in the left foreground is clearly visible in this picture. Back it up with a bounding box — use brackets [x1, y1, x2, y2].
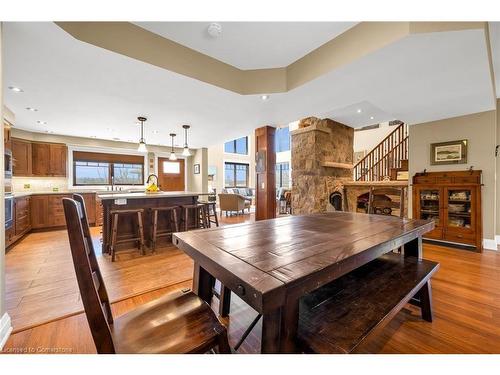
[63, 196, 231, 354]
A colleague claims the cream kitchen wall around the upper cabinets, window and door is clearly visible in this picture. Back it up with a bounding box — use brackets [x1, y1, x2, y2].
[10, 129, 207, 192]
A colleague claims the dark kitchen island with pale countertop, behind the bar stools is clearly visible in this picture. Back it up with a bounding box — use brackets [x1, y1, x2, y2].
[98, 191, 208, 253]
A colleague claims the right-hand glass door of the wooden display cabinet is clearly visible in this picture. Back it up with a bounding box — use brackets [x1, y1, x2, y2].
[445, 188, 474, 231]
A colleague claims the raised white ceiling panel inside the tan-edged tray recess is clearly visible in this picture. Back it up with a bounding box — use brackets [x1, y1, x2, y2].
[135, 22, 356, 70]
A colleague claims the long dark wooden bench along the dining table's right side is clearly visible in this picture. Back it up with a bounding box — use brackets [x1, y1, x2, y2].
[298, 253, 439, 353]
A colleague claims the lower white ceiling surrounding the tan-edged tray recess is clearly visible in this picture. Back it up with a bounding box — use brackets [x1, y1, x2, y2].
[3, 22, 498, 147]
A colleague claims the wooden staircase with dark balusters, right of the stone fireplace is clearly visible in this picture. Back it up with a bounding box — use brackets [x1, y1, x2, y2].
[353, 123, 408, 181]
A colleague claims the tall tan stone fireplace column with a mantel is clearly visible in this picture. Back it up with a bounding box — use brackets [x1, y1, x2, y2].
[291, 117, 354, 215]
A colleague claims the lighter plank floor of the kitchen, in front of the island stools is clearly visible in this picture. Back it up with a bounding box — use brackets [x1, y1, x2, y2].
[5, 228, 193, 332]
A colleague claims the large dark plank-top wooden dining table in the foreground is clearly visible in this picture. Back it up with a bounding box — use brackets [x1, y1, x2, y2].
[173, 212, 434, 353]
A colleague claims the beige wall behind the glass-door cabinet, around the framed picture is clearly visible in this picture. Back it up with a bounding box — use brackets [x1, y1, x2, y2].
[409, 111, 497, 240]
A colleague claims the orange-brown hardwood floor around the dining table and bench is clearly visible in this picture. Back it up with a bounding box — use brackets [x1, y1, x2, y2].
[4, 215, 500, 353]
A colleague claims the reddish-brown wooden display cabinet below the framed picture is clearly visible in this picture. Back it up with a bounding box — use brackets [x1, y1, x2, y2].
[413, 171, 483, 251]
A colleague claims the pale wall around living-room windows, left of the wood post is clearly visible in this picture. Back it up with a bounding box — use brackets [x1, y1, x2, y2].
[208, 134, 255, 193]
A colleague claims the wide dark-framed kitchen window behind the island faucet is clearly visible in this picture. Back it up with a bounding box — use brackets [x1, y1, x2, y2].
[73, 151, 144, 185]
